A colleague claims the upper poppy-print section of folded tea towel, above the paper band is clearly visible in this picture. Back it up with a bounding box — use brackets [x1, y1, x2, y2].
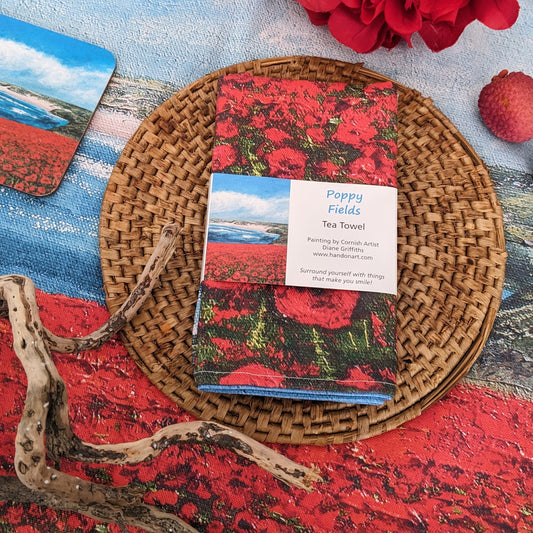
[212, 73, 397, 186]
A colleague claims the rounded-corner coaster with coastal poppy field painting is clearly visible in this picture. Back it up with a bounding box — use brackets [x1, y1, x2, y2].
[0, 15, 115, 196]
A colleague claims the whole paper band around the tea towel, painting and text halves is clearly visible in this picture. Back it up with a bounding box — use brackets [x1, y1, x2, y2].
[202, 173, 397, 294]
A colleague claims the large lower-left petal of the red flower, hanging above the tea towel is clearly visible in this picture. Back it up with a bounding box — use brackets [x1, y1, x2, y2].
[328, 4, 385, 54]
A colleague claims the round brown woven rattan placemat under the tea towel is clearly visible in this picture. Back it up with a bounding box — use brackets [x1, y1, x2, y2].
[100, 57, 506, 444]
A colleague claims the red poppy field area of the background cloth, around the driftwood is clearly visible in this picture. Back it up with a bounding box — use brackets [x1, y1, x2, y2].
[0, 293, 533, 533]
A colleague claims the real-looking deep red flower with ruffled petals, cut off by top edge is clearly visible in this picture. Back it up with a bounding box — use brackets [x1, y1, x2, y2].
[297, 0, 520, 53]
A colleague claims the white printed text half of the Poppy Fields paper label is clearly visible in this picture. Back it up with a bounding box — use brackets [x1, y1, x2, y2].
[285, 181, 397, 294]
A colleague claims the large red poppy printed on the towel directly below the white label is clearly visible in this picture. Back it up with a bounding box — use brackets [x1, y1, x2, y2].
[274, 286, 359, 329]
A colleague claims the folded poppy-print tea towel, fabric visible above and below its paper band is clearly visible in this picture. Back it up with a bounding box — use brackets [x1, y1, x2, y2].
[193, 74, 397, 405]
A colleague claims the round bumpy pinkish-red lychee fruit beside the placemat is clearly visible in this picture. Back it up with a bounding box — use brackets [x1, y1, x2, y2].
[478, 70, 533, 143]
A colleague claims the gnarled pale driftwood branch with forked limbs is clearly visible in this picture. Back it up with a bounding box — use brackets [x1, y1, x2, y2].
[0, 225, 320, 532]
